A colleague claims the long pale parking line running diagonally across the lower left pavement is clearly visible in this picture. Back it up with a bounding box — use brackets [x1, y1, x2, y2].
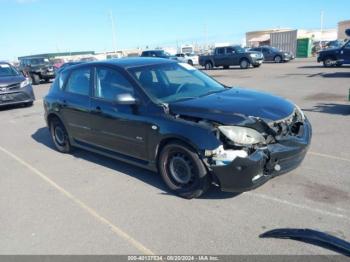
[0, 146, 154, 255]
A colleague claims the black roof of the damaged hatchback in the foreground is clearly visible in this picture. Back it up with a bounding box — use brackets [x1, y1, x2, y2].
[71, 57, 177, 69]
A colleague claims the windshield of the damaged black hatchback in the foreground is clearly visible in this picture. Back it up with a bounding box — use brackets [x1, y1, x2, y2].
[129, 63, 226, 103]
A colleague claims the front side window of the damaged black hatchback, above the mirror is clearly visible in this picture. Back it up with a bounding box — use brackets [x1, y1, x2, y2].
[95, 68, 134, 101]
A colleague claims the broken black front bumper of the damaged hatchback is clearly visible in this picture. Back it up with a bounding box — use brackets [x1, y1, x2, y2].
[210, 120, 312, 192]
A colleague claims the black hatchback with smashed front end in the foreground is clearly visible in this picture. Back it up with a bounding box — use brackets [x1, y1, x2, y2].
[44, 58, 312, 198]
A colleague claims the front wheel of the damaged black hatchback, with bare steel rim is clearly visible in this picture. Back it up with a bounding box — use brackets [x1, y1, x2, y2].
[158, 143, 211, 199]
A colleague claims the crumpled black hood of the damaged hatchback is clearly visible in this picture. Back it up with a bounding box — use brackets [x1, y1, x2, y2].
[169, 88, 295, 125]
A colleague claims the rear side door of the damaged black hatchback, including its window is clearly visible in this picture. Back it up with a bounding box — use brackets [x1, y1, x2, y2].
[58, 66, 92, 141]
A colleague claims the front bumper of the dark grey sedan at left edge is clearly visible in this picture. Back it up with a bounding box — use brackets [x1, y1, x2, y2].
[0, 85, 35, 106]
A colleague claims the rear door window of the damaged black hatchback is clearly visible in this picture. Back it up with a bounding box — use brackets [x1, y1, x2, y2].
[66, 68, 91, 96]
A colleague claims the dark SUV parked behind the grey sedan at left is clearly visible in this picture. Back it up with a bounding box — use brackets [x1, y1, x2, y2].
[18, 57, 55, 85]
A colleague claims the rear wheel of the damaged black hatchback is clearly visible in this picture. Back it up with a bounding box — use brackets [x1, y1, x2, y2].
[50, 118, 72, 154]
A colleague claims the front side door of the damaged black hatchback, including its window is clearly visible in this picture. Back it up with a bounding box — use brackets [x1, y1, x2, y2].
[90, 66, 151, 160]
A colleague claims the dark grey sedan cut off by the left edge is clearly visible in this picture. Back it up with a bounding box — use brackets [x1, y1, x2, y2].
[0, 62, 35, 107]
